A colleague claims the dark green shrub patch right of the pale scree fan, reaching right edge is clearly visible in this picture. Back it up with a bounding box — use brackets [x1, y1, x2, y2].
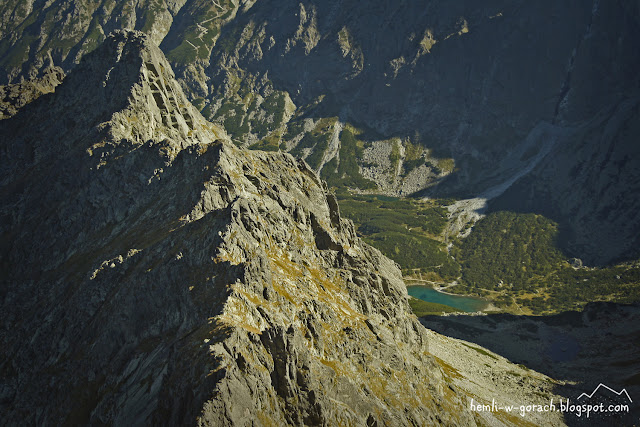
[451, 212, 640, 314]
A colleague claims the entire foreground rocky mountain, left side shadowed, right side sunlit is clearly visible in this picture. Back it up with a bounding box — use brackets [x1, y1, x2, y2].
[0, 32, 473, 426]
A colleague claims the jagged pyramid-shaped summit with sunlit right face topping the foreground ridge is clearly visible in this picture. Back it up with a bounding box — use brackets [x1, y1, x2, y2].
[84, 30, 228, 155]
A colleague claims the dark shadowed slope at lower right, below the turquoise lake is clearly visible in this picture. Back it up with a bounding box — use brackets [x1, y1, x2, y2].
[421, 302, 640, 425]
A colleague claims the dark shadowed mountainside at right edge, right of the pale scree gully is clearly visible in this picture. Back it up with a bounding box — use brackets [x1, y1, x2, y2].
[492, 96, 640, 265]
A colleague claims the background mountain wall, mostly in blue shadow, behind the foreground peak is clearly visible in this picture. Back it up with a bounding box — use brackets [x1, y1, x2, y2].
[0, 0, 640, 265]
